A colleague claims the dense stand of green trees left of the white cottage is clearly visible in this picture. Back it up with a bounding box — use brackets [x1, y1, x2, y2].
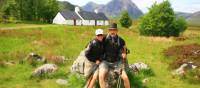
[0, 0, 59, 23]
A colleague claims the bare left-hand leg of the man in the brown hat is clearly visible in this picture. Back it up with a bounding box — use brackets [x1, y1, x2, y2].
[99, 62, 108, 88]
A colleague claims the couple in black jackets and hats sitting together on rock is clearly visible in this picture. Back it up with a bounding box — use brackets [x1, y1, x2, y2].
[85, 23, 130, 88]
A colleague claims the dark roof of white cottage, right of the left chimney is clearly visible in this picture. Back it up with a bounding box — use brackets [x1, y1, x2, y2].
[79, 11, 108, 20]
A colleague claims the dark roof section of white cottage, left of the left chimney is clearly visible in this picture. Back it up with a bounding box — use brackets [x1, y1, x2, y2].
[60, 10, 81, 19]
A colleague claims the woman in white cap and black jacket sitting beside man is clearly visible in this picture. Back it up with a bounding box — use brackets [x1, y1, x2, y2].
[85, 29, 104, 88]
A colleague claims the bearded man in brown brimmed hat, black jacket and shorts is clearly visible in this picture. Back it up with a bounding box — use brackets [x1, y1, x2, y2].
[99, 23, 130, 88]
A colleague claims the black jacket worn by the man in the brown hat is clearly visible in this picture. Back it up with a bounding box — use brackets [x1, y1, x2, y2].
[104, 35, 125, 62]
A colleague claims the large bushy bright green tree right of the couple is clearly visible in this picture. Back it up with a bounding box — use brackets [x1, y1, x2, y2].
[139, 0, 187, 37]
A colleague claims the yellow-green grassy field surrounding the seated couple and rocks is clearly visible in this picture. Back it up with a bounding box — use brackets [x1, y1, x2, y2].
[0, 24, 200, 88]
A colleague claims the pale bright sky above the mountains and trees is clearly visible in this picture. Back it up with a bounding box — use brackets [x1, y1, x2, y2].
[59, 0, 200, 13]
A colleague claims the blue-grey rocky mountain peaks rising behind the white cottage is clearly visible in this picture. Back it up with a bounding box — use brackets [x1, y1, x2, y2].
[82, 0, 143, 18]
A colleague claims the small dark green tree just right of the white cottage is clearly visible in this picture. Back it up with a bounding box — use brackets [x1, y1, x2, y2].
[119, 11, 132, 28]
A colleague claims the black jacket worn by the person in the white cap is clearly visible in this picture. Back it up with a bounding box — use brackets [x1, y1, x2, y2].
[85, 39, 104, 62]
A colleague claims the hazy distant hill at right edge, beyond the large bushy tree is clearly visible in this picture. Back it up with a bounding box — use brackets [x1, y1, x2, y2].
[187, 11, 200, 26]
